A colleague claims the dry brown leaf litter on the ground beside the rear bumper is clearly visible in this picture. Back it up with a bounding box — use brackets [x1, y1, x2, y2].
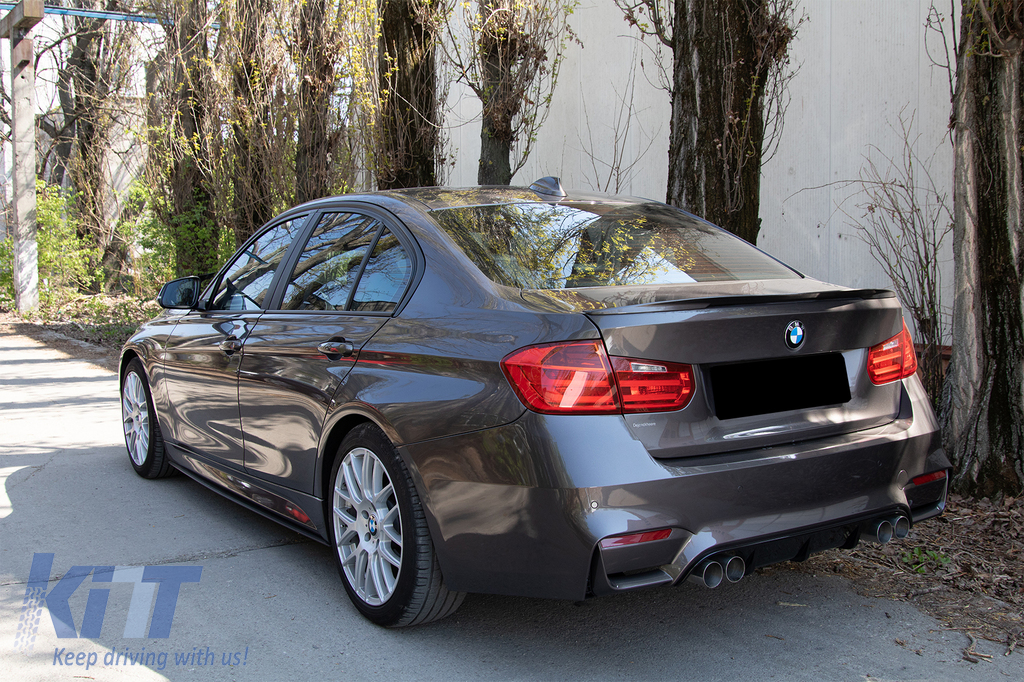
[774, 495, 1024, 662]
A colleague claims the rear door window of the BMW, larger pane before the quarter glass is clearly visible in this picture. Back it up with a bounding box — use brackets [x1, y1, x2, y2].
[281, 213, 381, 310]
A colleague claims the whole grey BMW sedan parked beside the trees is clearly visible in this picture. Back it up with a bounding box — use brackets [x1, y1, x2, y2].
[121, 178, 950, 627]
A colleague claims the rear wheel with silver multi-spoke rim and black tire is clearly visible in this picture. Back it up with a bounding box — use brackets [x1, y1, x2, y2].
[328, 424, 465, 628]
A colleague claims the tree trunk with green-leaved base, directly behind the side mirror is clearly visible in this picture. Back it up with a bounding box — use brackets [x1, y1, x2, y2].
[169, 2, 220, 275]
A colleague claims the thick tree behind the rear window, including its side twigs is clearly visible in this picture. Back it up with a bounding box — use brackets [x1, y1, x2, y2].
[615, 0, 802, 244]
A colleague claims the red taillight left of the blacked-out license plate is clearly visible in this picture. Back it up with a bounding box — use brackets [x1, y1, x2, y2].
[502, 339, 693, 415]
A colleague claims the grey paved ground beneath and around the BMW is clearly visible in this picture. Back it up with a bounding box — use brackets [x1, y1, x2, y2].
[0, 327, 1024, 682]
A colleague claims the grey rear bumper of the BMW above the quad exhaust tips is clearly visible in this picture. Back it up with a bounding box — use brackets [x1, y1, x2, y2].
[401, 372, 949, 599]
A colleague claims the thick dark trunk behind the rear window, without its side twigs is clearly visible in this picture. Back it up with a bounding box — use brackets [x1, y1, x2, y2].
[667, 0, 769, 244]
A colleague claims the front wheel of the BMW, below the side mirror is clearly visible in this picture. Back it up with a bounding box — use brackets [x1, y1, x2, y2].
[121, 357, 175, 478]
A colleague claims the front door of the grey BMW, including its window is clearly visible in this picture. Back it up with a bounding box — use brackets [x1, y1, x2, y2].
[163, 215, 306, 468]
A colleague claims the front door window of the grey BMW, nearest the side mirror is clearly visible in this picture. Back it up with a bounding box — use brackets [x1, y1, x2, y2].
[210, 215, 306, 310]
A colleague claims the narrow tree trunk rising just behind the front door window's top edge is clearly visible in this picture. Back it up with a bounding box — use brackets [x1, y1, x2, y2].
[231, 0, 273, 246]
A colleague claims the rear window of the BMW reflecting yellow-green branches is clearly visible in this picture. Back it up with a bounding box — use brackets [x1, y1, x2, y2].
[430, 202, 800, 289]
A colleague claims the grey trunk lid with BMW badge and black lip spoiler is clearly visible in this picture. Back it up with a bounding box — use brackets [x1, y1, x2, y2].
[577, 280, 902, 458]
